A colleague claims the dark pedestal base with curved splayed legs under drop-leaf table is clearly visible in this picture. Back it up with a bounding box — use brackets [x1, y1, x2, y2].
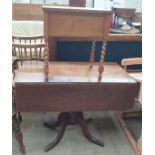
[44, 112, 104, 152]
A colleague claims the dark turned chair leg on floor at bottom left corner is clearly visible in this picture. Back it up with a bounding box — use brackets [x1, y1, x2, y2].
[12, 114, 25, 155]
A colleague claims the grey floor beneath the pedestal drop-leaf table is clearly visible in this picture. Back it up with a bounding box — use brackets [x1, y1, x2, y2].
[12, 112, 140, 155]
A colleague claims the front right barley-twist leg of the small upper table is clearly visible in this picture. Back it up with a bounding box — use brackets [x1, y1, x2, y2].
[98, 41, 107, 81]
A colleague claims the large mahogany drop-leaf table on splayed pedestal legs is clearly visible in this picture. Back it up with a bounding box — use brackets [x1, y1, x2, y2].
[15, 62, 138, 151]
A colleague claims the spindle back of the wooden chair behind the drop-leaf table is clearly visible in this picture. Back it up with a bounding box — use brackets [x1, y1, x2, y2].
[12, 36, 46, 64]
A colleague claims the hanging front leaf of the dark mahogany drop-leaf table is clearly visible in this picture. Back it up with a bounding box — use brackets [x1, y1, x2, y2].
[15, 83, 138, 112]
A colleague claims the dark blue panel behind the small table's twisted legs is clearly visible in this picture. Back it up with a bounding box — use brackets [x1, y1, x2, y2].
[57, 41, 142, 69]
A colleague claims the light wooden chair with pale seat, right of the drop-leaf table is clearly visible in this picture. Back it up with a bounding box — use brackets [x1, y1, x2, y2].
[116, 58, 142, 155]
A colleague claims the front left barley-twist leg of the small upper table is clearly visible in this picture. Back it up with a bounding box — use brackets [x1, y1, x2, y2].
[44, 41, 49, 81]
